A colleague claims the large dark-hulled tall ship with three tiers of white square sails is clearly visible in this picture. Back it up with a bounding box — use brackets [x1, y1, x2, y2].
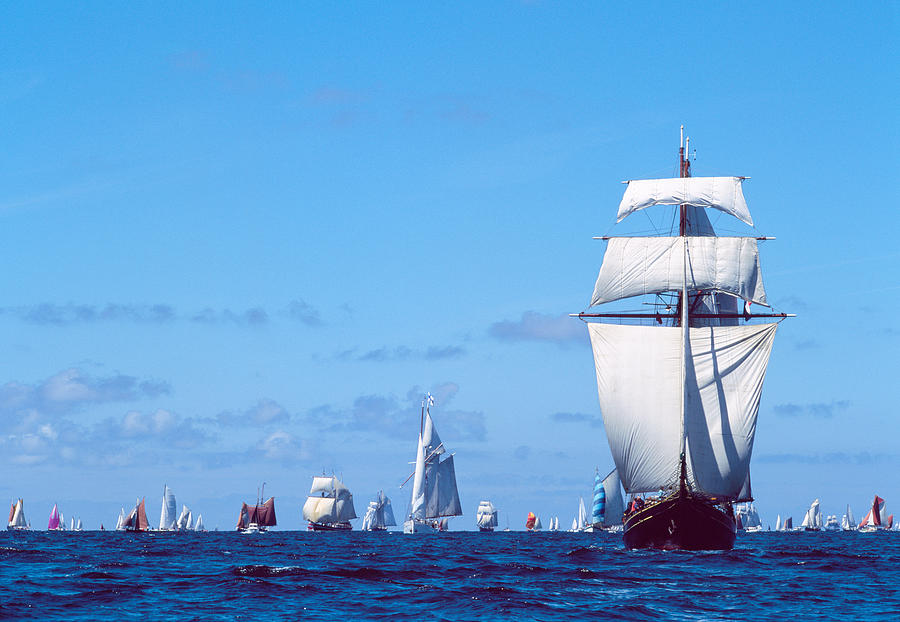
[575, 126, 788, 550]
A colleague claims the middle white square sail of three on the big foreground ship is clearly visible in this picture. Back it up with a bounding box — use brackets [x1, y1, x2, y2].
[591, 236, 767, 306]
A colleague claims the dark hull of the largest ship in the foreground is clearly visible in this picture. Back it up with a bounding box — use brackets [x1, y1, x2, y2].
[624, 496, 735, 551]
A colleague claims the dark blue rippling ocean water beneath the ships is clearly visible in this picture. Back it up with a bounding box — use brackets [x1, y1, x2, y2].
[0, 531, 900, 622]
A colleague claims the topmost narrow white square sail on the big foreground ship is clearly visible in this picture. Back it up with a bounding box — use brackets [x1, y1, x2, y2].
[616, 177, 753, 227]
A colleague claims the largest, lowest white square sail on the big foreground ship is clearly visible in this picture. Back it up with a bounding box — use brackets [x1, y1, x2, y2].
[588, 323, 776, 501]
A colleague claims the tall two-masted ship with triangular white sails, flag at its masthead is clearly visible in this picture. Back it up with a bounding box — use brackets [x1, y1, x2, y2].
[401, 393, 462, 533]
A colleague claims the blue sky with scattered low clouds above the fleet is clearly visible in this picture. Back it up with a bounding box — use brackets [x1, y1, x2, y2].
[0, 2, 900, 529]
